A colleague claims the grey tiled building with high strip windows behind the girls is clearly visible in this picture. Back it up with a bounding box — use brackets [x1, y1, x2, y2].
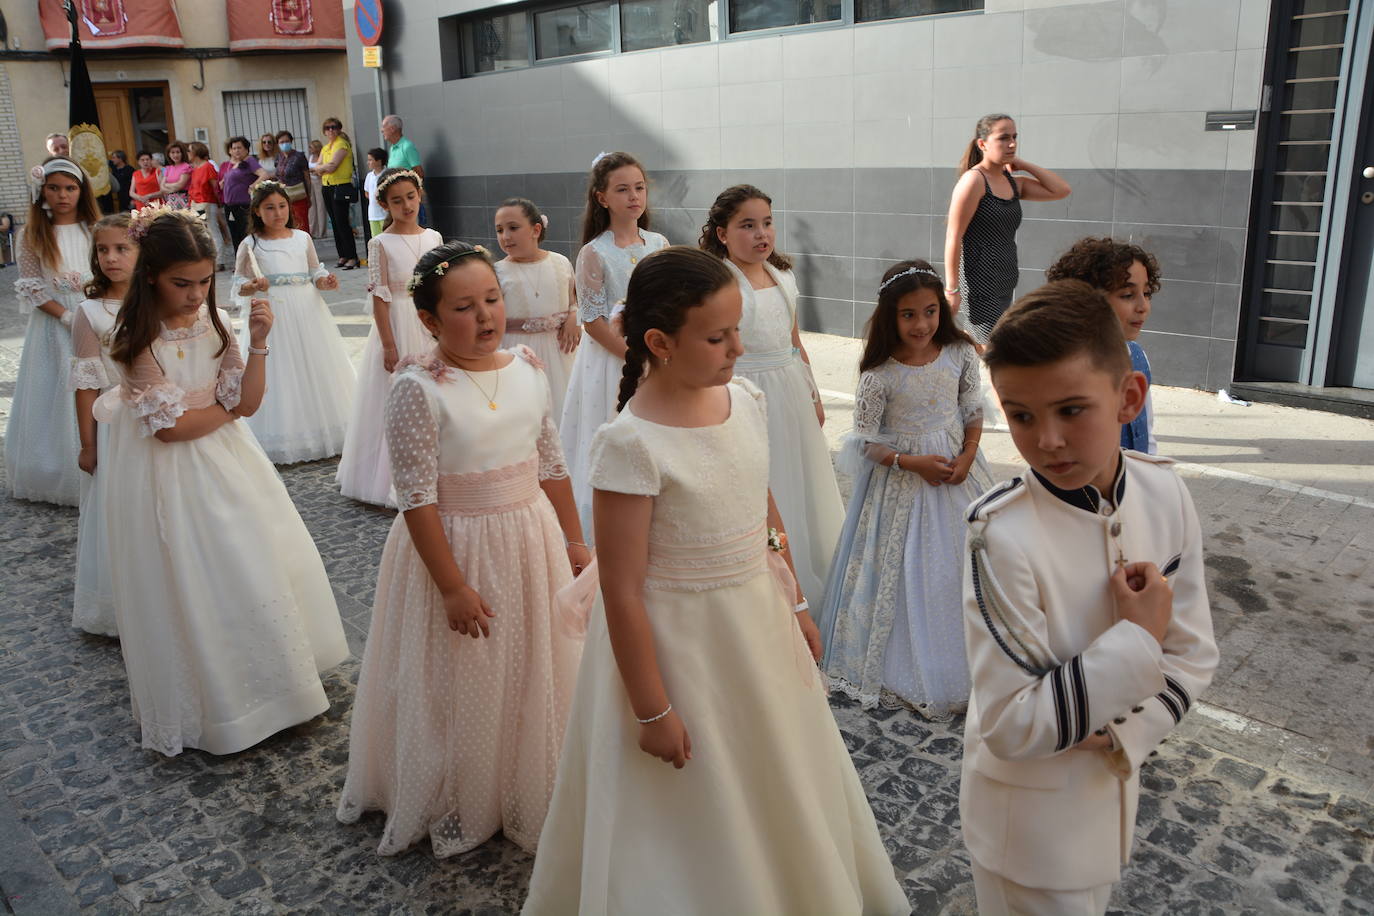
[345, 0, 1374, 398]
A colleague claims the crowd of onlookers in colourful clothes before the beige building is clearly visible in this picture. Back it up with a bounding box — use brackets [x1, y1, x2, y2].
[10, 114, 426, 271]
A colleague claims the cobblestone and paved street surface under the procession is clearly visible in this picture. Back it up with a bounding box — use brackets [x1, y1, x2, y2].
[0, 254, 1374, 916]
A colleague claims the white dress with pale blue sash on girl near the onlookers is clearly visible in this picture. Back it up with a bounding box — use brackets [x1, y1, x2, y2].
[232, 229, 356, 464]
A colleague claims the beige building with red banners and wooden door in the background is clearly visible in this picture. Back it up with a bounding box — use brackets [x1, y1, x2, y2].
[0, 0, 348, 218]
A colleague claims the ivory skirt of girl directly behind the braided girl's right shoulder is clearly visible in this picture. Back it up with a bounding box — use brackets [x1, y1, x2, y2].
[735, 354, 845, 602]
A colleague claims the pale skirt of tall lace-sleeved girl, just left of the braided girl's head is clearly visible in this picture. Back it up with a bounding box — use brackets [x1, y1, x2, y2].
[558, 336, 625, 544]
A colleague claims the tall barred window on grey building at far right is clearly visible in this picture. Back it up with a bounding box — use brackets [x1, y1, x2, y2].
[1256, 0, 1351, 354]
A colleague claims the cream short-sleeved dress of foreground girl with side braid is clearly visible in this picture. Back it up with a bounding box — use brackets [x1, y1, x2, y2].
[523, 379, 911, 916]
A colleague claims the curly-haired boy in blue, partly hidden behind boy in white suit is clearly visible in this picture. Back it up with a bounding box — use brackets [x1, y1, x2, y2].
[1044, 238, 1160, 455]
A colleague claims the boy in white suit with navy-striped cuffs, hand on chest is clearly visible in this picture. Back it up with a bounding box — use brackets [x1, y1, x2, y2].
[959, 280, 1217, 916]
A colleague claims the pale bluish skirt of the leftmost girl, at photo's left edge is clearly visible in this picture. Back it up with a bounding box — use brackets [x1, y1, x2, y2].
[4, 311, 85, 505]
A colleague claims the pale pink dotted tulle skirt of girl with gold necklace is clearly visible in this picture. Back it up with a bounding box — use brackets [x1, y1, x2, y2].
[338, 467, 581, 857]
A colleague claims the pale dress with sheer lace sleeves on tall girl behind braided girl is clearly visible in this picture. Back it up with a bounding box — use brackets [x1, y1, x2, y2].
[558, 229, 668, 544]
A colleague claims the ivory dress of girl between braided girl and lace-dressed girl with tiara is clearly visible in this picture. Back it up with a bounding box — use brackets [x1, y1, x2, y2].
[725, 260, 845, 602]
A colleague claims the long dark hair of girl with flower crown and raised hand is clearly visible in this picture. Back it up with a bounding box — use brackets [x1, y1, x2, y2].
[110, 207, 229, 368]
